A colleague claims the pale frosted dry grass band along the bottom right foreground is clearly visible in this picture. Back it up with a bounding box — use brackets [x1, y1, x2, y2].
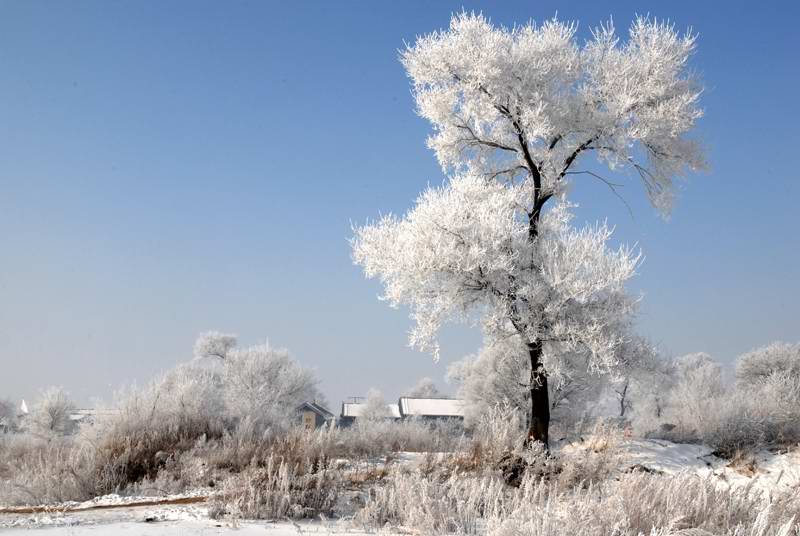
[354, 462, 800, 536]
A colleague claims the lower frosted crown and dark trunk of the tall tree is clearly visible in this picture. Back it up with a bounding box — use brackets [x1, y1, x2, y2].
[354, 179, 638, 441]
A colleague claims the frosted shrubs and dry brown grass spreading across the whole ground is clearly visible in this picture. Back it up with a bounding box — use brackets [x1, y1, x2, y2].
[0, 334, 800, 536]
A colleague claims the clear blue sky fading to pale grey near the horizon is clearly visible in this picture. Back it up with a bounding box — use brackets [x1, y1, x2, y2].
[0, 0, 800, 405]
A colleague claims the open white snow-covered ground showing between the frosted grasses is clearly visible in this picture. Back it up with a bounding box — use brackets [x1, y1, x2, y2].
[0, 439, 800, 536]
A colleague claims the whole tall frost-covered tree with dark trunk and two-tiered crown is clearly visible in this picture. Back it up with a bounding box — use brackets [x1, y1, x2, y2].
[353, 13, 703, 443]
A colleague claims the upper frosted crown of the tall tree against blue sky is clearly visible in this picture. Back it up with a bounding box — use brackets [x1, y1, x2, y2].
[402, 13, 704, 214]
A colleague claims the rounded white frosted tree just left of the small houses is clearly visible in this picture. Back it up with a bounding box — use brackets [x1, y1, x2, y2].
[223, 344, 319, 429]
